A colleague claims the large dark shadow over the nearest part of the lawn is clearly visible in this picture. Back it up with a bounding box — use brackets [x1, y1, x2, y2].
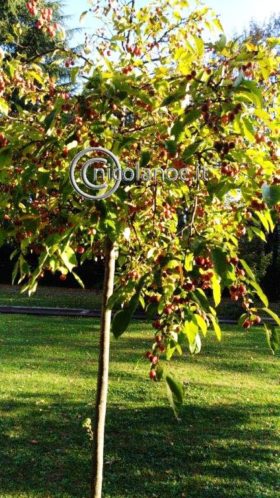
[0, 393, 277, 498]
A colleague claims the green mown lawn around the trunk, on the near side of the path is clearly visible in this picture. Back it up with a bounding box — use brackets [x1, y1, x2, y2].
[0, 315, 280, 498]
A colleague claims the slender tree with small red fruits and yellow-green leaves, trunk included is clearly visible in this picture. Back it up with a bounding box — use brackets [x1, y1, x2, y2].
[0, 0, 280, 498]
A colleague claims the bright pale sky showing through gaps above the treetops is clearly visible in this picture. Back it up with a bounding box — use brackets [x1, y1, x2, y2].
[63, 0, 280, 45]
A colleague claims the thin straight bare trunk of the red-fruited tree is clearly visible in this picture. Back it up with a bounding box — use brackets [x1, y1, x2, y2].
[90, 239, 115, 498]
